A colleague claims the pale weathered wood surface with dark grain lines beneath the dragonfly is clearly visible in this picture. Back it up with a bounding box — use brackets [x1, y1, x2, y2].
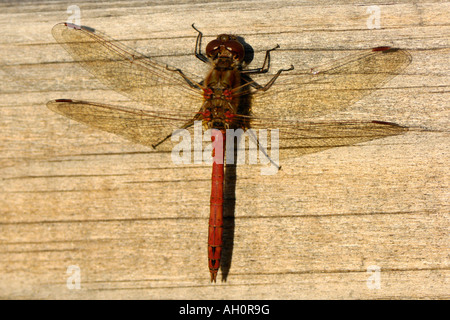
[0, 1, 450, 299]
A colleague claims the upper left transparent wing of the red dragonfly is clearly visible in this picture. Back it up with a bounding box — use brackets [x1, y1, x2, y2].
[52, 23, 202, 115]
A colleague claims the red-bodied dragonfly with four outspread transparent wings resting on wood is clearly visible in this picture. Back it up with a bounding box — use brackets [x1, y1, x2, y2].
[47, 23, 411, 282]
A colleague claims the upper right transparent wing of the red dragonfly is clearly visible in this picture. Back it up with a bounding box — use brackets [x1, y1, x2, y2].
[251, 47, 411, 120]
